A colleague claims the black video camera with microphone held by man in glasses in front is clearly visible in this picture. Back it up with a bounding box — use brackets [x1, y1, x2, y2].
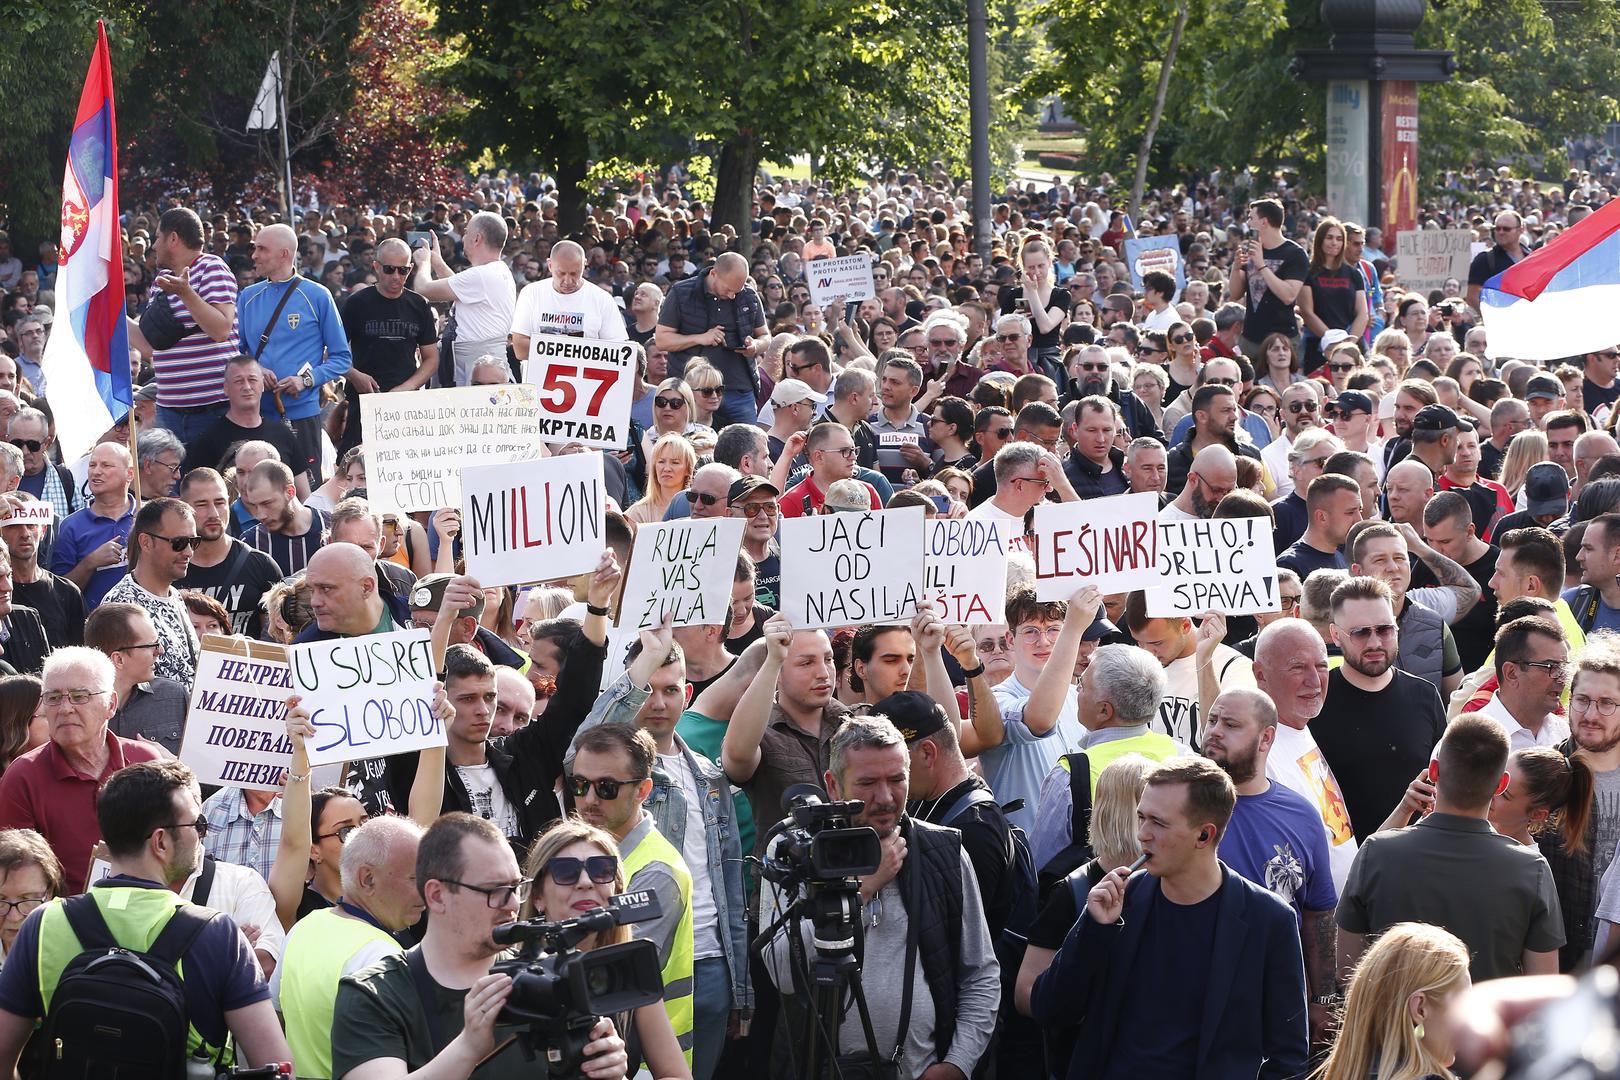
[489, 892, 664, 1080]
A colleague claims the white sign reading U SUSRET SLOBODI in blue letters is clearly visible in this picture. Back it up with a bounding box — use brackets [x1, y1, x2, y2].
[287, 630, 446, 764]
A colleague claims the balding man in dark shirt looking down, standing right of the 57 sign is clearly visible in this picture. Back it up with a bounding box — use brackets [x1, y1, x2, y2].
[653, 251, 771, 427]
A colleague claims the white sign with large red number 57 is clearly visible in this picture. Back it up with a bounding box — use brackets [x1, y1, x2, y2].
[523, 341, 642, 450]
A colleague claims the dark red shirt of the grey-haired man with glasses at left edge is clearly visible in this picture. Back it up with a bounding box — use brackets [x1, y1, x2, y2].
[0, 732, 162, 895]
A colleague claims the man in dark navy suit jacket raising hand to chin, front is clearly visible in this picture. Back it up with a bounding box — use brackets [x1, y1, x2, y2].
[1030, 758, 1309, 1080]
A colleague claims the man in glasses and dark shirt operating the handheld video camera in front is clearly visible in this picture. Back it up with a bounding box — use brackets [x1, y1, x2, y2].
[332, 813, 629, 1080]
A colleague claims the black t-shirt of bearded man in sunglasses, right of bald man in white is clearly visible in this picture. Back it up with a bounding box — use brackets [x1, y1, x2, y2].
[1311, 667, 1445, 842]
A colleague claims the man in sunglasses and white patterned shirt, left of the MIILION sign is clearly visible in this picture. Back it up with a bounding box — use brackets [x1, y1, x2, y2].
[102, 497, 203, 691]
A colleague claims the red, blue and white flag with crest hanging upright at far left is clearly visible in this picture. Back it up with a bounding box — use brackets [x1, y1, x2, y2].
[42, 23, 133, 461]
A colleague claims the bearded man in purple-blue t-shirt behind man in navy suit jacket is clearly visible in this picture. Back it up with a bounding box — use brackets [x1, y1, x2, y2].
[1202, 688, 1338, 1044]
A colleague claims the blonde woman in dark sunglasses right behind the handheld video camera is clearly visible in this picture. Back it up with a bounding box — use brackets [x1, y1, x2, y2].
[518, 818, 692, 1080]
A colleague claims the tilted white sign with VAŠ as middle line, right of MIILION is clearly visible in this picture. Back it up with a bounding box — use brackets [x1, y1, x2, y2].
[619, 518, 744, 630]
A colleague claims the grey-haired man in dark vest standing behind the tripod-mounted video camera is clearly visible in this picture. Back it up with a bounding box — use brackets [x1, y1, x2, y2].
[761, 716, 1001, 1080]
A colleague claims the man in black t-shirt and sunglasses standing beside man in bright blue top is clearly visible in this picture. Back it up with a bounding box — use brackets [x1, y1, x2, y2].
[335, 236, 439, 466]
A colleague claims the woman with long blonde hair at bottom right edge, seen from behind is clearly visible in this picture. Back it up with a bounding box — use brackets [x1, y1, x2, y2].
[1312, 923, 1471, 1080]
